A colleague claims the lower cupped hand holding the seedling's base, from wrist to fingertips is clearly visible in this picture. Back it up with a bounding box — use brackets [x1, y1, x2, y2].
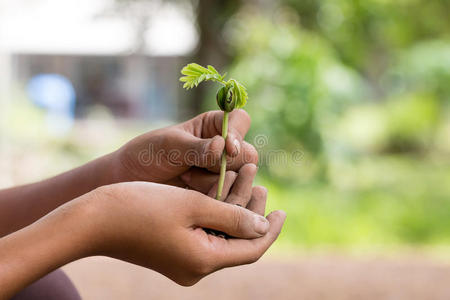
[86, 182, 285, 286]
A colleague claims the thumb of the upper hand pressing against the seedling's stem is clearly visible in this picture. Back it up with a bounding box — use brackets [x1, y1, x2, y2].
[177, 135, 225, 168]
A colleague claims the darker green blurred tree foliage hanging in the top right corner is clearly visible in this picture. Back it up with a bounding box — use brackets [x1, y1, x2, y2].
[281, 0, 450, 96]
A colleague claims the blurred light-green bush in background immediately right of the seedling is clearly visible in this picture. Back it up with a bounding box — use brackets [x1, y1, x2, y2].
[223, 13, 342, 177]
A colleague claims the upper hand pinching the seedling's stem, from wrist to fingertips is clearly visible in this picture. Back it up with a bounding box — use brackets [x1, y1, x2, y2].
[113, 110, 258, 187]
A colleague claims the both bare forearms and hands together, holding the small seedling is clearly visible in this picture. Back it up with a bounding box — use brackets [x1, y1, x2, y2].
[0, 110, 285, 299]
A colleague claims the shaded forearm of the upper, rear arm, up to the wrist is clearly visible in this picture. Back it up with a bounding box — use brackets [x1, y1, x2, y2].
[0, 154, 117, 237]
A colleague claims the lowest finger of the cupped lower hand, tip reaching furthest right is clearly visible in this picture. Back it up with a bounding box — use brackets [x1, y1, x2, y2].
[210, 210, 286, 269]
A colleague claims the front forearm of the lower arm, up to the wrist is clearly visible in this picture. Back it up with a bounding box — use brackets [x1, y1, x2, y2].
[0, 195, 96, 300]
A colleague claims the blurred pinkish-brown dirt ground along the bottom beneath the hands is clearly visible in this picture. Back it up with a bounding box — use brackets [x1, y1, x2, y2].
[64, 256, 450, 300]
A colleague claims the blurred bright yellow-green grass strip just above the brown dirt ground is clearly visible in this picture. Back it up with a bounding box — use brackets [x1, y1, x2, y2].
[260, 155, 450, 249]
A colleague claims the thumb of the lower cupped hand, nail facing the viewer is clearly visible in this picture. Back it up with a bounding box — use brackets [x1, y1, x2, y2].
[192, 193, 269, 239]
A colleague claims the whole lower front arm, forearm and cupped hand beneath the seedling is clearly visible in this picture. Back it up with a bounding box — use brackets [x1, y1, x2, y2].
[0, 169, 286, 299]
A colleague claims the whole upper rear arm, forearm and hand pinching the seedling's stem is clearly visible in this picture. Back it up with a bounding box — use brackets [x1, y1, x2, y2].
[0, 110, 258, 237]
